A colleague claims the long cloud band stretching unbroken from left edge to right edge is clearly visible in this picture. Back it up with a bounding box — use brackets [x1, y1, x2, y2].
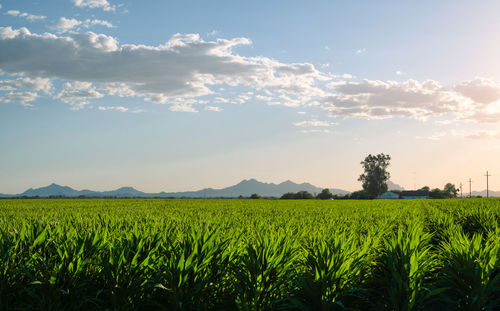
[0, 25, 500, 122]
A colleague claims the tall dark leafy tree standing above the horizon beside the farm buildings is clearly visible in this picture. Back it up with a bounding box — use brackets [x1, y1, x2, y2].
[358, 153, 391, 198]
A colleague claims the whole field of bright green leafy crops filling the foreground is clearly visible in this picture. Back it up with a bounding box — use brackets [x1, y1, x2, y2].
[0, 199, 500, 310]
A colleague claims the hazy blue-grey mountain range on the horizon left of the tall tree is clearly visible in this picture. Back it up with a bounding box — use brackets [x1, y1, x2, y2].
[0, 179, 349, 198]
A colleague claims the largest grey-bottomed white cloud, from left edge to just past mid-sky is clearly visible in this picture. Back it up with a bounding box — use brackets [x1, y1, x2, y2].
[0, 27, 329, 111]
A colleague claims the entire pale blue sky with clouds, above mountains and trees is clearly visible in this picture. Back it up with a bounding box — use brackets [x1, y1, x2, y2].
[0, 0, 500, 193]
